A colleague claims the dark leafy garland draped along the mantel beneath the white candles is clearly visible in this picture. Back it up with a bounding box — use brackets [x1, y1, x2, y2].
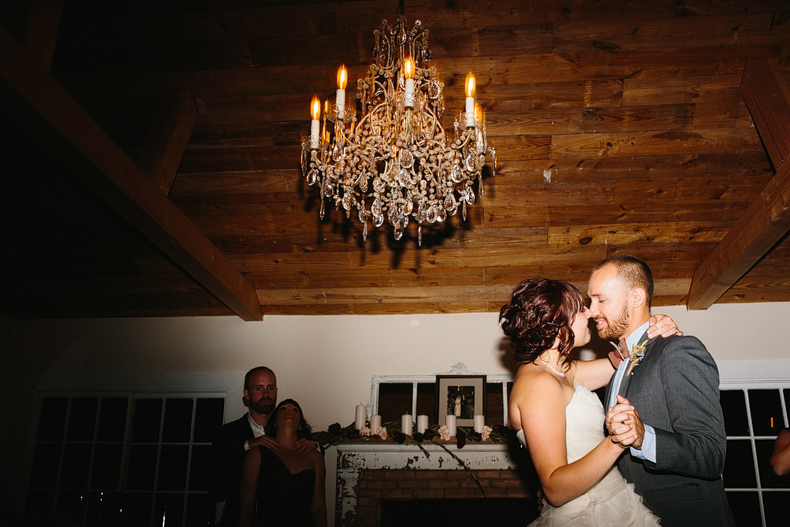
[313, 421, 513, 498]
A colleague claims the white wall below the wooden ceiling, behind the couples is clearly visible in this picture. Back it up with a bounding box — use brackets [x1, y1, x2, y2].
[0, 303, 790, 507]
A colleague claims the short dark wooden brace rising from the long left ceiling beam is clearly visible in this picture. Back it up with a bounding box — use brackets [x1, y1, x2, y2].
[137, 88, 197, 196]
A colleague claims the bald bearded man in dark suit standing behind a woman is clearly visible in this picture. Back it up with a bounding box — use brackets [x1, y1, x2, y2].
[213, 366, 318, 527]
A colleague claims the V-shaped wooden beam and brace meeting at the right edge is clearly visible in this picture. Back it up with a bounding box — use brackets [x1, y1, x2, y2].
[687, 58, 790, 309]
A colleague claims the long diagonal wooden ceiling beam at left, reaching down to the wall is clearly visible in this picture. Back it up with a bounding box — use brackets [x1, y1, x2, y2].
[0, 26, 263, 320]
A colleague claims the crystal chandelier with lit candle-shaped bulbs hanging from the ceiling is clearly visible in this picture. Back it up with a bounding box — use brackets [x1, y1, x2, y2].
[302, 15, 496, 245]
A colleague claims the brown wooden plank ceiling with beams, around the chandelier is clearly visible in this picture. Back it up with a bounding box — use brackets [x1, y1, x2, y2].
[0, 0, 790, 320]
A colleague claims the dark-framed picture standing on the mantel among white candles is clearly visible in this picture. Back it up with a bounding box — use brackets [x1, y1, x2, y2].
[436, 375, 486, 427]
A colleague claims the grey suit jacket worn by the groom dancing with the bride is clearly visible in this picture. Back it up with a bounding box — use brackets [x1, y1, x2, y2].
[606, 333, 735, 527]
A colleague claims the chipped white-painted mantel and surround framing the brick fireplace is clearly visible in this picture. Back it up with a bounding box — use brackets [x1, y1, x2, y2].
[336, 440, 525, 525]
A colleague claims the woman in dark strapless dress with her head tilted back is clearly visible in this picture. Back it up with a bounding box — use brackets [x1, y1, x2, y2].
[240, 399, 326, 527]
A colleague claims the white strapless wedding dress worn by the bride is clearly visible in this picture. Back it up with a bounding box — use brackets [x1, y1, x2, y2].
[516, 385, 659, 527]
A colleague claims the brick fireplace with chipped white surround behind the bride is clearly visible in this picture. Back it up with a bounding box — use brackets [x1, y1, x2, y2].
[335, 441, 537, 527]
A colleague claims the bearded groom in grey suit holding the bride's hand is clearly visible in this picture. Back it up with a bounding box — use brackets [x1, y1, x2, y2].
[587, 254, 735, 527]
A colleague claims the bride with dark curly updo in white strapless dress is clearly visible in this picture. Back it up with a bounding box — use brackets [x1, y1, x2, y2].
[499, 278, 676, 527]
